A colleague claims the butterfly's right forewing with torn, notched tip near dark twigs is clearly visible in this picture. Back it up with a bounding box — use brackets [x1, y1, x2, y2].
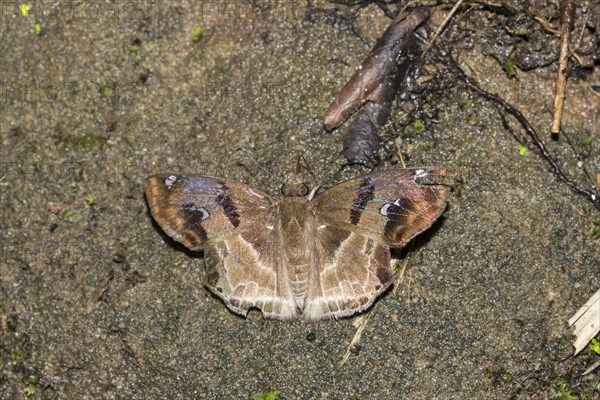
[313, 168, 451, 247]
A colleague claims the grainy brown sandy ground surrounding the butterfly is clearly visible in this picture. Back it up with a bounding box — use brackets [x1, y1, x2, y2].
[0, 1, 600, 399]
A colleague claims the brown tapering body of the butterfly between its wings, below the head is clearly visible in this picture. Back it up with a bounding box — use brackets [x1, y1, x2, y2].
[278, 196, 312, 309]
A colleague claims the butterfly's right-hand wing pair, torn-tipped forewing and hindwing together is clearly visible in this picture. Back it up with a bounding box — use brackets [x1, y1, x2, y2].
[304, 168, 451, 319]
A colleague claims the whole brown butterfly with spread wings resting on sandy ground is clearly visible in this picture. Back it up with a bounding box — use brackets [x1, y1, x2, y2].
[145, 167, 451, 320]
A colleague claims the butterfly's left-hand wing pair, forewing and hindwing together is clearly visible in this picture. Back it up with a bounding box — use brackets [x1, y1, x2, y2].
[145, 174, 297, 319]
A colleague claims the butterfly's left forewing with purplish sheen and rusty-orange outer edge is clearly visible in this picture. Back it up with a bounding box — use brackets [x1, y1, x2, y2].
[144, 174, 276, 250]
